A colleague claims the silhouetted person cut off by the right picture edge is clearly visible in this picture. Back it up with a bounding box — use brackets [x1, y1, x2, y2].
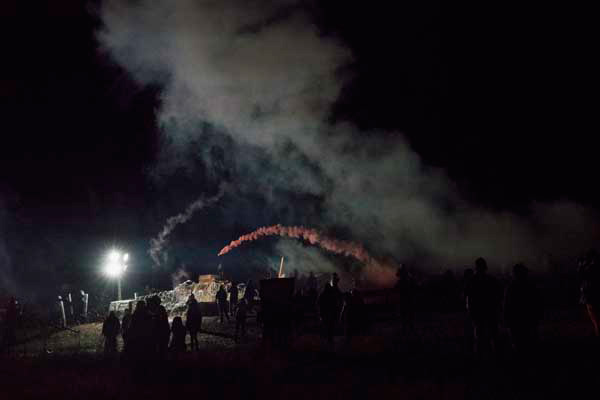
[579, 250, 600, 337]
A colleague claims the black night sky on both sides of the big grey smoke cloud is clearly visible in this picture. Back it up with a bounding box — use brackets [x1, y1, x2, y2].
[0, 0, 600, 296]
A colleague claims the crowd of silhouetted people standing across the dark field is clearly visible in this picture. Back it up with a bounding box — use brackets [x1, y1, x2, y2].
[95, 251, 600, 359]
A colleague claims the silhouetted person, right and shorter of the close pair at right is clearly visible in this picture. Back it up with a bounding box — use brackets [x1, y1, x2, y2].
[504, 264, 541, 354]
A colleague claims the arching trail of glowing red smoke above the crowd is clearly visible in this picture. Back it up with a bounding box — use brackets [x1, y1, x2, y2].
[219, 224, 373, 264]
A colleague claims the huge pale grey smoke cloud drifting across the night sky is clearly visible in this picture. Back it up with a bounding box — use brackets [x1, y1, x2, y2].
[98, 0, 599, 279]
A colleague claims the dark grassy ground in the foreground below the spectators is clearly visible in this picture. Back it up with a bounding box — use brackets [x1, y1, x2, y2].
[0, 308, 600, 399]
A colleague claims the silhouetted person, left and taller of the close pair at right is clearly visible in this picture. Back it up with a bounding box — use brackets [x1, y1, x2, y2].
[468, 257, 502, 355]
